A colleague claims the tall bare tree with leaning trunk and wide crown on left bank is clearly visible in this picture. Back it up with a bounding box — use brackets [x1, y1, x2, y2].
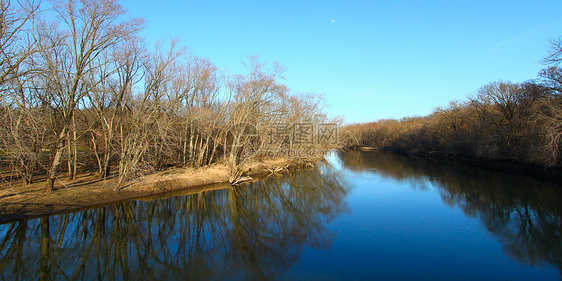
[43, 0, 142, 191]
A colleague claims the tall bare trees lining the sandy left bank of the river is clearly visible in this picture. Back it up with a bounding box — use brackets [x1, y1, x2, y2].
[0, 0, 330, 190]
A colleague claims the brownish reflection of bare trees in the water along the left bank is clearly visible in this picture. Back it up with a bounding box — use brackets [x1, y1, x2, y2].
[0, 164, 350, 280]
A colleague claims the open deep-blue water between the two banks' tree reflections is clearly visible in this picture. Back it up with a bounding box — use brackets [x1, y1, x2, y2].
[283, 152, 561, 280]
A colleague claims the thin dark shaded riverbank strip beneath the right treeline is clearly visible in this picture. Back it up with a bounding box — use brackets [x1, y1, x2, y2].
[347, 147, 562, 186]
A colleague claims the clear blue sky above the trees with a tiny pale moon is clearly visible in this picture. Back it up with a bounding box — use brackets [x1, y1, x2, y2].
[121, 0, 562, 122]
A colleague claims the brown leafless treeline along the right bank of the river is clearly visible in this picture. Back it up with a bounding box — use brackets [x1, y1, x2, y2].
[341, 37, 562, 167]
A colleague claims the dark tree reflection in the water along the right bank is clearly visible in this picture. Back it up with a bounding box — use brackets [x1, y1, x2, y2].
[339, 151, 562, 275]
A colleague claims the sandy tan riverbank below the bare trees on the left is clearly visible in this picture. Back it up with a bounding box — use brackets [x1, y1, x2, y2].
[0, 158, 309, 223]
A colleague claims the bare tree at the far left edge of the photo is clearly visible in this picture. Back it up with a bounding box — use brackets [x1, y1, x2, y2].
[0, 1, 47, 183]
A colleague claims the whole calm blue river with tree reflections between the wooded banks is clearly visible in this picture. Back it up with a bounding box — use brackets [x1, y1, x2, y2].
[0, 151, 562, 280]
